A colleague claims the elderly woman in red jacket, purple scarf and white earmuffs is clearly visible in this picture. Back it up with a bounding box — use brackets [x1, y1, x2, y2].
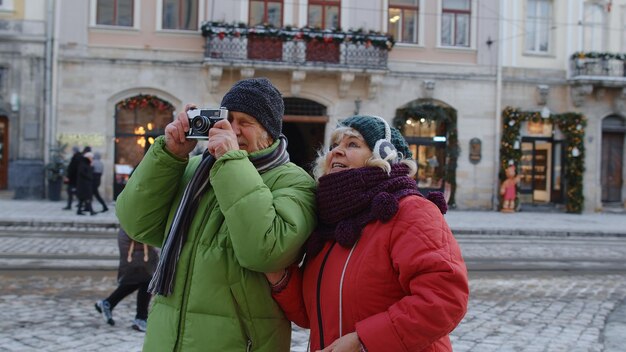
[266, 116, 469, 352]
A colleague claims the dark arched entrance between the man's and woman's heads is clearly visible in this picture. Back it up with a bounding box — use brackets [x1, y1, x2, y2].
[283, 98, 328, 173]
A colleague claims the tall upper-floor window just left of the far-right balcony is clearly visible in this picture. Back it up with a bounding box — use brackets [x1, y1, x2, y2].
[525, 0, 552, 54]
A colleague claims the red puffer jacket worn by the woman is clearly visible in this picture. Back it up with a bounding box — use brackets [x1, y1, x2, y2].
[274, 196, 469, 352]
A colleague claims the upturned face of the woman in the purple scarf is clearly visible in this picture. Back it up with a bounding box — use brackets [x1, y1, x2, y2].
[325, 134, 372, 175]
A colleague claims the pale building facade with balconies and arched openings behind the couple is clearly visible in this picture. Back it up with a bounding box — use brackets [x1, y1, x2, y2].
[3, 0, 626, 212]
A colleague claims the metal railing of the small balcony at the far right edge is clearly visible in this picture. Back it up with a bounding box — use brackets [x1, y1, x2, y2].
[570, 52, 626, 80]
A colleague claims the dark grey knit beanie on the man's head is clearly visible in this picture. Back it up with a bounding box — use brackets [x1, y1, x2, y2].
[220, 78, 285, 140]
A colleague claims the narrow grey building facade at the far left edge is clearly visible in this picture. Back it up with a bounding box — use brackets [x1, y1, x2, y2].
[0, 0, 49, 198]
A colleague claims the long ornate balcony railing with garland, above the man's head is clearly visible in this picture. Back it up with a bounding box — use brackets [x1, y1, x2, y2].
[202, 23, 394, 70]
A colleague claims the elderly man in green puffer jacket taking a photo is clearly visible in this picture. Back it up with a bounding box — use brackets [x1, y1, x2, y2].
[116, 78, 316, 352]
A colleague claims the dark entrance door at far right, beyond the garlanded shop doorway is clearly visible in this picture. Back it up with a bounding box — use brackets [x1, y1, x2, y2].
[601, 132, 624, 203]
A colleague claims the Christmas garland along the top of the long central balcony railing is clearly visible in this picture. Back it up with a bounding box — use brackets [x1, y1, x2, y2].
[201, 21, 395, 51]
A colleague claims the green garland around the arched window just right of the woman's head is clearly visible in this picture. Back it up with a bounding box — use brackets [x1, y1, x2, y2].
[393, 101, 461, 207]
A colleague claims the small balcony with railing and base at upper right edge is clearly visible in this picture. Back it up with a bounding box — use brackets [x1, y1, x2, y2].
[569, 52, 626, 87]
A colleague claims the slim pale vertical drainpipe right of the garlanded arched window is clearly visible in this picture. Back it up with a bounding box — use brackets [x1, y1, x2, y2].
[492, 0, 507, 211]
